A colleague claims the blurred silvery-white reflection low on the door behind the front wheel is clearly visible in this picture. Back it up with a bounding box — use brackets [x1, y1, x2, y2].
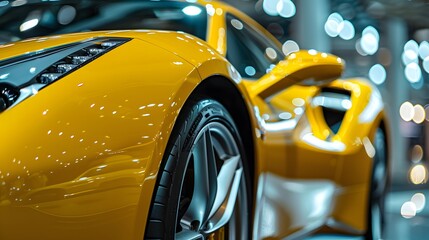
[254, 173, 335, 239]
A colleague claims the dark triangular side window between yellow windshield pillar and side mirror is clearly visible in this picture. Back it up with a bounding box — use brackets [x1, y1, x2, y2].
[226, 14, 284, 79]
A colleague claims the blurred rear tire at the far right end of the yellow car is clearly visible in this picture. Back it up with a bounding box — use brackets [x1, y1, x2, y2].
[365, 128, 388, 240]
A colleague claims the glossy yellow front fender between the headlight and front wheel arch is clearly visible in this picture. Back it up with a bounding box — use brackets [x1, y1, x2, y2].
[0, 35, 201, 239]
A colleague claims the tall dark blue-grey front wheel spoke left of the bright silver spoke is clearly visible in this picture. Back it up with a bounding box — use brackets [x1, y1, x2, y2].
[181, 128, 217, 230]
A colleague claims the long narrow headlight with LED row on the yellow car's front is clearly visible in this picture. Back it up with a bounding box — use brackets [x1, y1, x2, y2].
[0, 38, 130, 112]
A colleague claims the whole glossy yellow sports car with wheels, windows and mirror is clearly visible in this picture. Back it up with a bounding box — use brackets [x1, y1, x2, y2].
[0, 0, 388, 240]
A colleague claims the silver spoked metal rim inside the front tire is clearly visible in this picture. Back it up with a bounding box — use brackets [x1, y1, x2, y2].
[175, 122, 247, 239]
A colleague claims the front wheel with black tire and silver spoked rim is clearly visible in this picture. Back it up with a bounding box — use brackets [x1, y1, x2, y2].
[145, 99, 252, 240]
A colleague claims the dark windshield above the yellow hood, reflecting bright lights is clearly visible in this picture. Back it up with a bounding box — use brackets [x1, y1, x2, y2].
[0, 0, 207, 43]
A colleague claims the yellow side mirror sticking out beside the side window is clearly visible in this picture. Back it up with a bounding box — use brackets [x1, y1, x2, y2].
[251, 50, 345, 99]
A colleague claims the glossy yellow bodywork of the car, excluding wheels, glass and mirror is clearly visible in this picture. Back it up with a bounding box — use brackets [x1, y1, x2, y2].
[0, 1, 385, 239]
